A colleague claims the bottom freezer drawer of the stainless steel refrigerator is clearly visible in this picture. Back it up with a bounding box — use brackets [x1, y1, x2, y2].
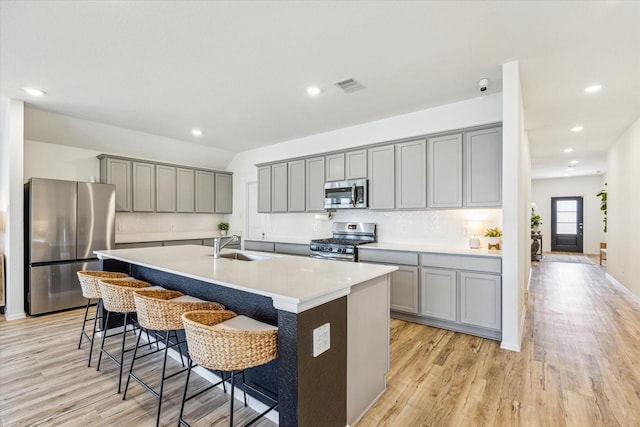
[26, 260, 99, 315]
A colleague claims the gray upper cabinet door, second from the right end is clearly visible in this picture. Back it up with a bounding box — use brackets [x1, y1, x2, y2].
[427, 134, 462, 208]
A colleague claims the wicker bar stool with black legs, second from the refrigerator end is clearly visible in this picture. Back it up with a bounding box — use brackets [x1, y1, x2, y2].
[97, 278, 151, 393]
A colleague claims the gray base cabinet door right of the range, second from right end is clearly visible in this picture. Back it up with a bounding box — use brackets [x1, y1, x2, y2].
[420, 268, 458, 321]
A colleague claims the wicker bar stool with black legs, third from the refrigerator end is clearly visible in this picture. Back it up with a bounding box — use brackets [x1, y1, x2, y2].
[122, 288, 224, 426]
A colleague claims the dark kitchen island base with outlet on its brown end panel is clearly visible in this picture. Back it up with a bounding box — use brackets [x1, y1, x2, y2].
[100, 246, 396, 427]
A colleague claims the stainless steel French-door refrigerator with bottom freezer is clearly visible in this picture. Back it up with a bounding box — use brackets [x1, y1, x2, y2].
[25, 178, 115, 315]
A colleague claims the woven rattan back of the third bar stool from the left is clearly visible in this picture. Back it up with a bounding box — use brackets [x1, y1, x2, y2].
[133, 289, 224, 331]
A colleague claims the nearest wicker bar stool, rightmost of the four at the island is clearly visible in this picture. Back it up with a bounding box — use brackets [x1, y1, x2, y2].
[178, 311, 278, 426]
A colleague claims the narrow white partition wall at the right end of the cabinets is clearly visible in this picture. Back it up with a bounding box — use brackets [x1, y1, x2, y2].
[501, 61, 531, 351]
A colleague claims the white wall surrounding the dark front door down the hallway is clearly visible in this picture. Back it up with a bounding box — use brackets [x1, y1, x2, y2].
[531, 175, 606, 254]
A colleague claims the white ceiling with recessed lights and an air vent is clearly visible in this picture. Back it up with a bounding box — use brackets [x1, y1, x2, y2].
[0, 0, 640, 178]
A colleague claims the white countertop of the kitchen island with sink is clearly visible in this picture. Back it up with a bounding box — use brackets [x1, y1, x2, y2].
[95, 245, 397, 313]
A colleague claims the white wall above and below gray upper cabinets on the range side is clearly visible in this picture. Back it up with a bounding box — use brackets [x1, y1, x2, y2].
[228, 94, 502, 246]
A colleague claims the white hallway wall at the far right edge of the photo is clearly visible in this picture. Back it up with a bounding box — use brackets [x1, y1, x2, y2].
[607, 118, 640, 297]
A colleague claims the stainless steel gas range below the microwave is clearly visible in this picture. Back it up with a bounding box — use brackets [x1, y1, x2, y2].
[309, 222, 377, 262]
